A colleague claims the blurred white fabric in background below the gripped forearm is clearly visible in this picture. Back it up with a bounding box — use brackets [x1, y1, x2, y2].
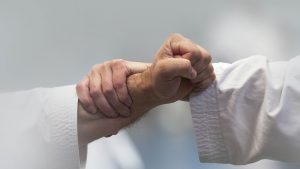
[86, 130, 145, 169]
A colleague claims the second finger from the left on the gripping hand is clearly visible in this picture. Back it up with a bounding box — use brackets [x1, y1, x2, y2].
[90, 69, 118, 117]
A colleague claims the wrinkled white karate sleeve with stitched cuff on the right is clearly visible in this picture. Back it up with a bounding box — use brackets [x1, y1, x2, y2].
[190, 56, 300, 164]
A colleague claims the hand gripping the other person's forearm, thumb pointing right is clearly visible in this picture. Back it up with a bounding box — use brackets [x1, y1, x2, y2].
[76, 59, 149, 117]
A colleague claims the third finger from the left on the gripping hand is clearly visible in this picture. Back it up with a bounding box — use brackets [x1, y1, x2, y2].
[101, 64, 130, 116]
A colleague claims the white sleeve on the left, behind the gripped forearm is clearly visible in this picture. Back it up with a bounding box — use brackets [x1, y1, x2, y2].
[0, 86, 80, 169]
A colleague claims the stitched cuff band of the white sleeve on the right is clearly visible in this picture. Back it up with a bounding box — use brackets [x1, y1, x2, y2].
[190, 66, 229, 163]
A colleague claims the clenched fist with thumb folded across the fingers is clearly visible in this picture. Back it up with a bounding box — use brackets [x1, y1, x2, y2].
[148, 34, 215, 103]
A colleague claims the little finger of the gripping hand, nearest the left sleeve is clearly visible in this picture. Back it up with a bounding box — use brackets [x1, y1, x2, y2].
[76, 76, 97, 114]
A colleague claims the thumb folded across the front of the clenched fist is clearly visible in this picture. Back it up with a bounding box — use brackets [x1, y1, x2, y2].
[156, 58, 197, 80]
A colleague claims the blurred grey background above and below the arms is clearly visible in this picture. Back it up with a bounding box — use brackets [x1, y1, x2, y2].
[0, 0, 300, 169]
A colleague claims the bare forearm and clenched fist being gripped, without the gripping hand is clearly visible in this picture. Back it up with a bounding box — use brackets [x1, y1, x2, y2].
[77, 34, 215, 146]
